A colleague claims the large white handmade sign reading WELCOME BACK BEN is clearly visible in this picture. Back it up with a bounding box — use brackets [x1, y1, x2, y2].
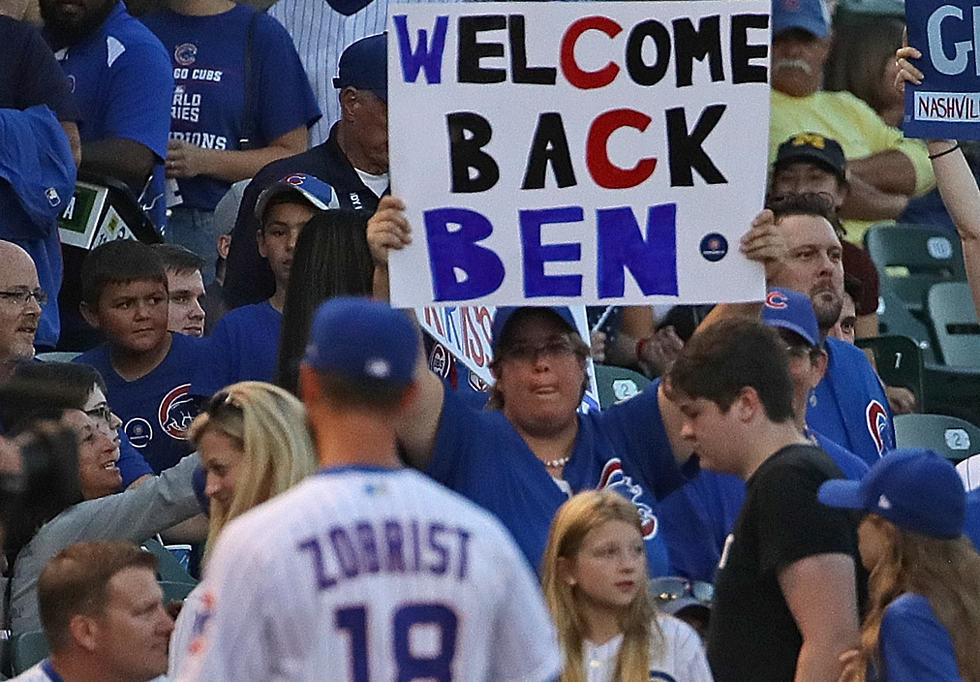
[388, 0, 769, 307]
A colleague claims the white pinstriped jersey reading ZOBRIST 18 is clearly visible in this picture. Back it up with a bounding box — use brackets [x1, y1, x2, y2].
[179, 467, 560, 682]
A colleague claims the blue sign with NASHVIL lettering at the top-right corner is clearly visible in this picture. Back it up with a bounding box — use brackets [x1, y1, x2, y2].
[902, 0, 980, 140]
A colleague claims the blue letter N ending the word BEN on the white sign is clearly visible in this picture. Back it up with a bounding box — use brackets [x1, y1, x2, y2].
[596, 204, 677, 298]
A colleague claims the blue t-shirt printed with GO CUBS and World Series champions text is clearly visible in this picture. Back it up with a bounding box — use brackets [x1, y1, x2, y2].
[143, 4, 320, 210]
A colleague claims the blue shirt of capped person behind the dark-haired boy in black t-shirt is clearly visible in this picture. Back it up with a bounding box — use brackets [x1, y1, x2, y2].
[657, 424, 868, 582]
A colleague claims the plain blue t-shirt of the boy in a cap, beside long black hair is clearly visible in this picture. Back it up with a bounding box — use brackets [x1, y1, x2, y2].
[191, 301, 282, 396]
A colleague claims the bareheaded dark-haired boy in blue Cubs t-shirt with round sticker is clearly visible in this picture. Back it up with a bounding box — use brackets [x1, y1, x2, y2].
[75, 240, 205, 473]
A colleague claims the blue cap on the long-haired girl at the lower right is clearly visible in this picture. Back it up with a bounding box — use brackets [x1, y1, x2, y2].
[818, 448, 966, 538]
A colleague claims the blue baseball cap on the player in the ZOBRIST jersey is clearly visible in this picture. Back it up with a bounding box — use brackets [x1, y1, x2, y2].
[303, 297, 418, 385]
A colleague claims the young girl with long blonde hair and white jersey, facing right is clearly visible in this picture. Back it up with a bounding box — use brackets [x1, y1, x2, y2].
[542, 490, 712, 682]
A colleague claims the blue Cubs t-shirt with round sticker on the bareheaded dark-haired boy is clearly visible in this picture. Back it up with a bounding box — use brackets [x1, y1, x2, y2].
[74, 334, 206, 474]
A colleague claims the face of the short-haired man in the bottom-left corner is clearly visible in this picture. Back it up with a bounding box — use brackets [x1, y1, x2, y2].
[94, 567, 174, 682]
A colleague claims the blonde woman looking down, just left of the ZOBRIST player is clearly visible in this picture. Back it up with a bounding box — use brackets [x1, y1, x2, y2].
[168, 381, 318, 678]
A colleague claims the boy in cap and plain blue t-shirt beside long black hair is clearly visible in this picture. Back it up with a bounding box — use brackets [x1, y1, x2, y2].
[194, 174, 340, 395]
